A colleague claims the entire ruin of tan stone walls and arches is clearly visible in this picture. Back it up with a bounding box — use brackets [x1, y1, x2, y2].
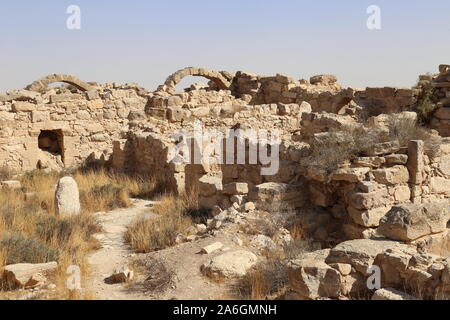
[0, 65, 450, 299]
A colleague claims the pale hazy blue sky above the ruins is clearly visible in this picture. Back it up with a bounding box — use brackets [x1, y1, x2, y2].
[0, 0, 450, 91]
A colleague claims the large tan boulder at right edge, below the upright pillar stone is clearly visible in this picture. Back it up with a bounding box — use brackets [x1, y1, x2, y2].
[378, 202, 450, 241]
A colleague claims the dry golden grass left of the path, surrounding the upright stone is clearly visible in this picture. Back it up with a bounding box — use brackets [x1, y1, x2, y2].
[0, 170, 156, 299]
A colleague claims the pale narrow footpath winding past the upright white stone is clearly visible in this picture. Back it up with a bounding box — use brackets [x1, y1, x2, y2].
[88, 199, 154, 300]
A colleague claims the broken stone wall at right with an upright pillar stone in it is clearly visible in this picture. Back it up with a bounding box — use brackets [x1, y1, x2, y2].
[309, 136, 450, 239]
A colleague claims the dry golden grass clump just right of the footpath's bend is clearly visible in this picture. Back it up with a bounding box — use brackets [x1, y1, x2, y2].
[125, 195, 198, 253]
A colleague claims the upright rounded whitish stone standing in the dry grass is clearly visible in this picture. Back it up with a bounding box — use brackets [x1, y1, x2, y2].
[55, 177, 81, 217]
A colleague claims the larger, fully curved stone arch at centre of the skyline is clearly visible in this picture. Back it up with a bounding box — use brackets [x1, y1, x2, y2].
[160, 67, 231, 90]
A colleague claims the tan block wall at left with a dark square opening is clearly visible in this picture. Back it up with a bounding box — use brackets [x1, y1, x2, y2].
[0, 84, 147, 170]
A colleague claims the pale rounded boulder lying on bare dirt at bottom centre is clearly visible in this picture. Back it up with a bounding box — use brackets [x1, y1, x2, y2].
[201, 250, 258, 279]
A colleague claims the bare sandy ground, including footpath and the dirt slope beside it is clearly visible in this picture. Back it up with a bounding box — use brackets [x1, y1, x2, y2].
[89, 200, 244, 300]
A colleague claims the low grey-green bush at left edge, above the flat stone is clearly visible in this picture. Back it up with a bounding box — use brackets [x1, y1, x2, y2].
[0, 233, 58, 264]
